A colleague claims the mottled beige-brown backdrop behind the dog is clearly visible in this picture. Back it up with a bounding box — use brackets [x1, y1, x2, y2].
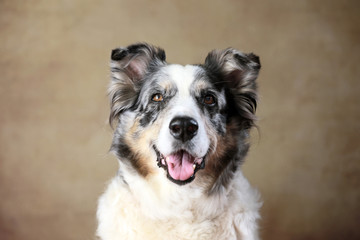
[0, 0, 360, 240]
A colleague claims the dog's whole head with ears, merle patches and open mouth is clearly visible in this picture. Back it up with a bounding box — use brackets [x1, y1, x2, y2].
[109, 44, 260, 188]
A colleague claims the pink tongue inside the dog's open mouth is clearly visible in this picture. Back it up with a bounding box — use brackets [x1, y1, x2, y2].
[167, 151, 195, 181]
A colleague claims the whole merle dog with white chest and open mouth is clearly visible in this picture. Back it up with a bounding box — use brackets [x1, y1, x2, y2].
[97, 43, 261, 240]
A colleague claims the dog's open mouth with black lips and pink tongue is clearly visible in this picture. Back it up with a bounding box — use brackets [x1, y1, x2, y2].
[154, 146, 205, 185]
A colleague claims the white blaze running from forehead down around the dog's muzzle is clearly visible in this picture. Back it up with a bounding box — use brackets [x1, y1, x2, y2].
[157, 65, 210, 158]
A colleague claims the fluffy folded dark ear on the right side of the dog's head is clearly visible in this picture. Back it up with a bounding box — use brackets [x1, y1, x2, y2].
[204, 48, 261, 128]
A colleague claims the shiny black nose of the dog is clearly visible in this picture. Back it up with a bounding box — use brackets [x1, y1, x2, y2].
[169, 117, 199, 142]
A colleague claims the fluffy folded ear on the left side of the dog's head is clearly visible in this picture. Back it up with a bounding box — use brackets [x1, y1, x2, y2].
[108, 43, 165, 125]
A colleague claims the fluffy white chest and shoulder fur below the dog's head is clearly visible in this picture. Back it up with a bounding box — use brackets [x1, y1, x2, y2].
[97, 166, 261, 240]
